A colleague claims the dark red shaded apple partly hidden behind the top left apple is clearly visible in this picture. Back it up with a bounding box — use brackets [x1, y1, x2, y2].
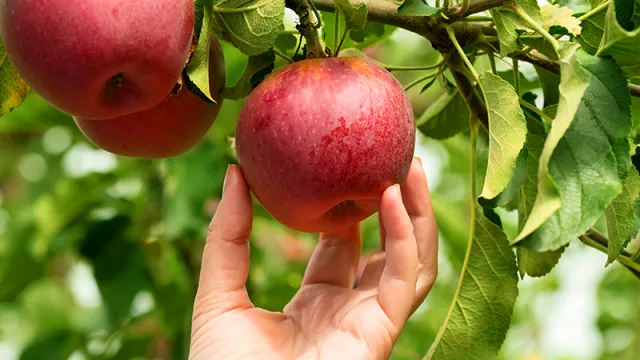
[74, 36, 226, 159]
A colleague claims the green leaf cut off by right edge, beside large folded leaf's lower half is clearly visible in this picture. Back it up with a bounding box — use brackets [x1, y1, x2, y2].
[604, 166, 640, 265]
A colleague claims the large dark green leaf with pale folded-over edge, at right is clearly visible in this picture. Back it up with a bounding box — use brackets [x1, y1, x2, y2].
[514, 45, 631, 252]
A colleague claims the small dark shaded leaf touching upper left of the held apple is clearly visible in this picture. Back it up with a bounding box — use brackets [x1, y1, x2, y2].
[222, 51, 276, 100]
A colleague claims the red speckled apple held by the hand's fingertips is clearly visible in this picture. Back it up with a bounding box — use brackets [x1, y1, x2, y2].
[235, 57, 416, 233]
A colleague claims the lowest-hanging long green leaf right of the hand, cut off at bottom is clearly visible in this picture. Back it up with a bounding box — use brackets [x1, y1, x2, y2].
[425, 209, 518, 360]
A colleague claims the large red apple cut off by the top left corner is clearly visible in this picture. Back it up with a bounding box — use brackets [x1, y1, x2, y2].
[0, 0, 194, 119]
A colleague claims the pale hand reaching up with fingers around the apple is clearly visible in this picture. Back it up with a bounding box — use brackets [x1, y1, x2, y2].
[189, 159, 438, 360]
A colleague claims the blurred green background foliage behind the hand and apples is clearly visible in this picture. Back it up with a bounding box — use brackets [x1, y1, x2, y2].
[0, 21, 640, 360]
